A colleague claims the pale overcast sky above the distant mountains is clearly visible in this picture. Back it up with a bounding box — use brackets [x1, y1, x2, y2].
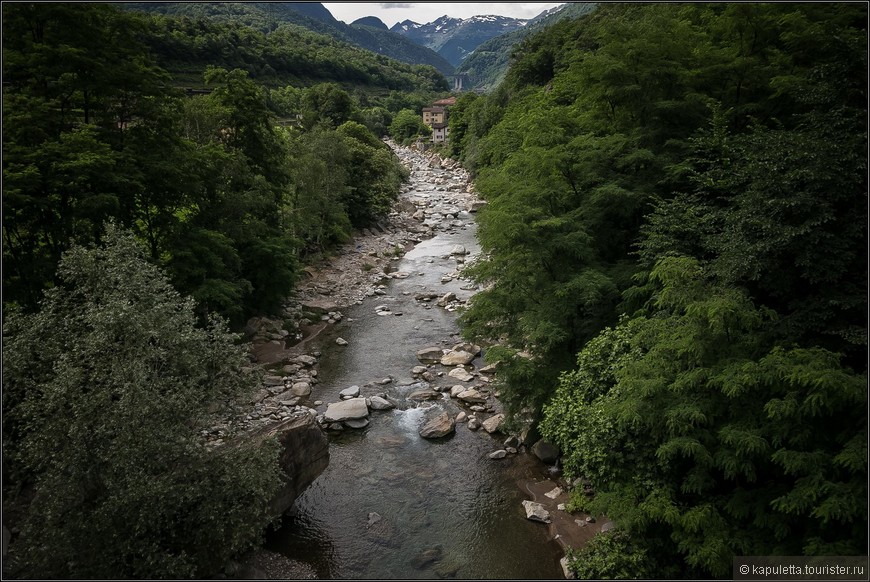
[323, 2, 564, 27]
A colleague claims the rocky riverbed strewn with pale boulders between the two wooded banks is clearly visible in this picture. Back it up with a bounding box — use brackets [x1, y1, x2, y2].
[220, 144, 597, 578]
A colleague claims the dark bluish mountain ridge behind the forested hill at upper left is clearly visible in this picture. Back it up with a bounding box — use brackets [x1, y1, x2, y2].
[118, 2, 454, 75]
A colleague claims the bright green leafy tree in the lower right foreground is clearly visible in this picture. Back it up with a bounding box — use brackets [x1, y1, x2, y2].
[541, 257, 867, 577]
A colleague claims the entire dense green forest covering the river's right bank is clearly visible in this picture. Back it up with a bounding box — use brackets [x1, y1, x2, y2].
[450, 3, 867, 578]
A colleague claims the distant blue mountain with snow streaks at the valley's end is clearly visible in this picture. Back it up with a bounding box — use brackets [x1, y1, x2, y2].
[390, 15, 530, 66]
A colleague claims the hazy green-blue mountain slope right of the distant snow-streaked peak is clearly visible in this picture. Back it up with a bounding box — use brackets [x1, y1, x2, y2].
[456, 2, 596, 92]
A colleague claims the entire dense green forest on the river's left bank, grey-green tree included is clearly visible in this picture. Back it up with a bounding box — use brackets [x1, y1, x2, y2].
[3, 3, 447, 579]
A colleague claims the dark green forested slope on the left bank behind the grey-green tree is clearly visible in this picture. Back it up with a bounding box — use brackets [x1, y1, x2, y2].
[3, 4, 444, 322]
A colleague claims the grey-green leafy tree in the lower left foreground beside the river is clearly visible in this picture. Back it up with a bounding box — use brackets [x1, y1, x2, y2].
[3, 225, 280, 579]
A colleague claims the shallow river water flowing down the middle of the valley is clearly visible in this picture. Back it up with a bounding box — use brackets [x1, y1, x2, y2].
[266, 147, 563, 579]
